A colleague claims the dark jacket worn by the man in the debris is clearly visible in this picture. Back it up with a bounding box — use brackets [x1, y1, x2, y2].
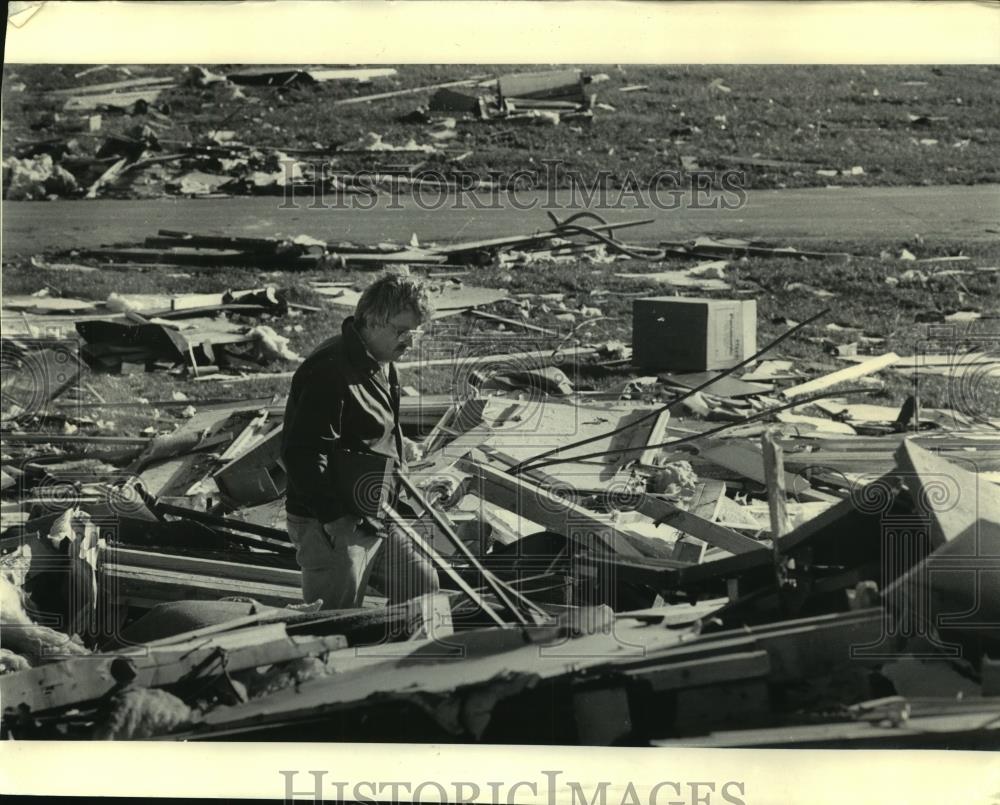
[281, 317, 403, 523]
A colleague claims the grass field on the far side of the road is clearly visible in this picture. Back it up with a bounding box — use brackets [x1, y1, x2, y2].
[3, 65, 1000, 193]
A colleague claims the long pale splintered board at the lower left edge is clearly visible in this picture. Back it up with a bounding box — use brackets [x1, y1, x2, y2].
[0, 623, 347, 713]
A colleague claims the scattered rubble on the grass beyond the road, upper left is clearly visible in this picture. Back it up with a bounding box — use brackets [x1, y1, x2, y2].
[3, 66, 612, 200]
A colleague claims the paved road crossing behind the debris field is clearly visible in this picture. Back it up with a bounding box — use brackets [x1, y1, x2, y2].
[2, 185, 1000, 258]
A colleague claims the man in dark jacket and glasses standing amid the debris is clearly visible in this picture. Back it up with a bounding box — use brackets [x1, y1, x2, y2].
[281, 275, 438, 609]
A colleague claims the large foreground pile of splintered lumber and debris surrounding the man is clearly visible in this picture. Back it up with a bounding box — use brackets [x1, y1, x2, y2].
[0, 274, 1000, 748]
